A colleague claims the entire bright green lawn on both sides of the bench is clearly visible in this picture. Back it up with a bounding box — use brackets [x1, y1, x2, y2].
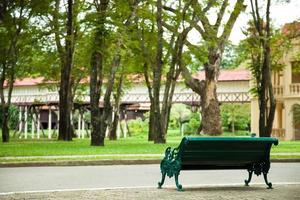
[0, 129, 300, 163]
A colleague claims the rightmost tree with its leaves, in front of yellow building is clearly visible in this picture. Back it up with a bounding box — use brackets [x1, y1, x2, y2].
[248, 0, 286, 137]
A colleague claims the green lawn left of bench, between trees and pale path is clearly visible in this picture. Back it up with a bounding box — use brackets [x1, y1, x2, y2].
[0, 138, 180, 157]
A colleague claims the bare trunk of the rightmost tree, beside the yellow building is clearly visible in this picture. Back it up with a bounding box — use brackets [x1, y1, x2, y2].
[250, 0, 276, 137]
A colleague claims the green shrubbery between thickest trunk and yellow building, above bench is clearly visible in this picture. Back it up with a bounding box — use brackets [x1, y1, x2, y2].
[221, 104, 251, 131]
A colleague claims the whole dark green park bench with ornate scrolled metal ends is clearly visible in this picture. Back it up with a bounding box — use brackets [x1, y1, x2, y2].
[158, 137, 278, 191]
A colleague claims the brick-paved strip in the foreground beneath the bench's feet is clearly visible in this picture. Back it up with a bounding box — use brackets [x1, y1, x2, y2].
[0, 185, 300, 200]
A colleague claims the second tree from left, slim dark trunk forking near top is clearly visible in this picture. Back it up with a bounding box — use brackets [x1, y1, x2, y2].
[53, 0, 78, 141]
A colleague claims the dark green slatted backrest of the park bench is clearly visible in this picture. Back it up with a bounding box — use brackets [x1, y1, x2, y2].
[179, 137, 278, 169]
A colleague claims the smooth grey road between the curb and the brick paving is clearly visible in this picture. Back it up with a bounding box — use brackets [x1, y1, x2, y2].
[0, 163, 300, 193]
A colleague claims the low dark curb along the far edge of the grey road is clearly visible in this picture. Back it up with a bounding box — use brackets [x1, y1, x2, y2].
[0, 159, 300, 168]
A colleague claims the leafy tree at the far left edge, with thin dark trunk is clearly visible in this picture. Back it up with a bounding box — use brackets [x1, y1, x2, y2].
[0, 0, 34, 142]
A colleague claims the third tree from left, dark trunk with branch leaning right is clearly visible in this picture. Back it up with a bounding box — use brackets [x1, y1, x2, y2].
[90, 0, 139, 146]
